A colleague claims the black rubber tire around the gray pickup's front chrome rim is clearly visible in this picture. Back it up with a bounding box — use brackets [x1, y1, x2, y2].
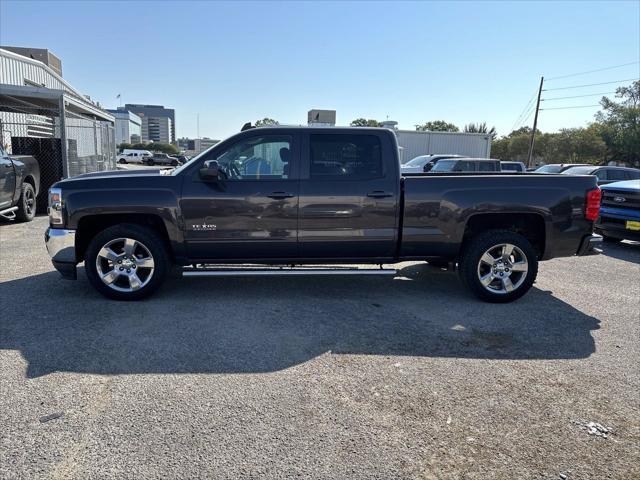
[84, 223, 171, 300]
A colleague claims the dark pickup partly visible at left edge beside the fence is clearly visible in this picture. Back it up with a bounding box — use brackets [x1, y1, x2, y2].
[0, 146, 40, 222]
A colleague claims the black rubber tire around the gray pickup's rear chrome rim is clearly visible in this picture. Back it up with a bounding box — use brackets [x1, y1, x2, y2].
[459, 230, 538, 303]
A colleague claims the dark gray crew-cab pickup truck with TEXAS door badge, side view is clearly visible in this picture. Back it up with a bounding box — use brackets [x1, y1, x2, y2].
[45, 127, 602, 302]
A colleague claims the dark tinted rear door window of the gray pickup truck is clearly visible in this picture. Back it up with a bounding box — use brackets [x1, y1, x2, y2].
[309, 134, 383, 180]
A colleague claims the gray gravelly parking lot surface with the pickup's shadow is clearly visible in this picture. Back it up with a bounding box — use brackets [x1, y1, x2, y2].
[0, 217, 640, 479]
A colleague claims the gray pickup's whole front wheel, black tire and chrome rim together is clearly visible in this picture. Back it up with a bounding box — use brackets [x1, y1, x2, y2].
[84, 224, 169, 300]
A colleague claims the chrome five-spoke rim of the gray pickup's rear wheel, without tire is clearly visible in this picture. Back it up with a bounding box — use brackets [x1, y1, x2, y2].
[478, 243, 529, 294]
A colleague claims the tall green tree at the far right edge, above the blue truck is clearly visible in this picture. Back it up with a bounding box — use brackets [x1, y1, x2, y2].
[594, 80, 640, 167]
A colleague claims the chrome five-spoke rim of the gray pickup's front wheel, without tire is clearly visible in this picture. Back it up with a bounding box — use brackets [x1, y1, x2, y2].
[96, 238, 154, 292]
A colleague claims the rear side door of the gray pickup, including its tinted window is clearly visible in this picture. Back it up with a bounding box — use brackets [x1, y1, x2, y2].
[298, 134, 398, 258]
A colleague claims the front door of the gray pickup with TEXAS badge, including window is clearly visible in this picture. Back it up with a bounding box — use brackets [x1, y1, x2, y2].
[180, 134, 299, 260]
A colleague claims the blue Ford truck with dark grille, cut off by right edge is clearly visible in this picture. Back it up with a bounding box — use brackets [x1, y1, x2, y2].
[595, 180, 640, 242]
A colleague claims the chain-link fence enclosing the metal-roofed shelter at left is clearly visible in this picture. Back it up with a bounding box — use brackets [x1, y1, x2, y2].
[0, 102, 116, 210]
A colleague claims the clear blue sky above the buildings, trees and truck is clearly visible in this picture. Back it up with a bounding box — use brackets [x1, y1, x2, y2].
[0, 0, 640, 138]
